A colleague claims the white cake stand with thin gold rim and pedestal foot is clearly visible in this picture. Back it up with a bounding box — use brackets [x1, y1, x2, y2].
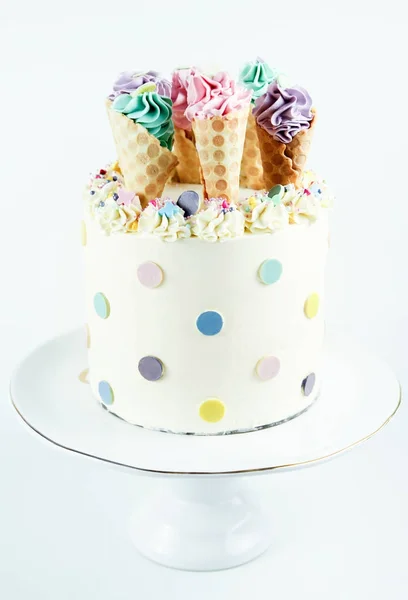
[11, 331, 401, 570]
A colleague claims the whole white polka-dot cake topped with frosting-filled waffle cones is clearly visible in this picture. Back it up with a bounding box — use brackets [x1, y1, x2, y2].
[82, 59, 332, 435]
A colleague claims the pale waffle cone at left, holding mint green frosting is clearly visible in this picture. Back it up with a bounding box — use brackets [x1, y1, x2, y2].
[107, 100, 178, 206]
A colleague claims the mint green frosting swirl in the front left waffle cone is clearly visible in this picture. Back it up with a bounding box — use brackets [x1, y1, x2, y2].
[112, 92, 174, 150]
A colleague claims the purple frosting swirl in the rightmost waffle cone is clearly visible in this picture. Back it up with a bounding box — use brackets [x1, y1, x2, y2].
[253, 81, 313, 144]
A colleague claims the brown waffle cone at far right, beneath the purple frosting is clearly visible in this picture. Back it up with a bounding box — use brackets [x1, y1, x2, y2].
[256, 111, 316, 189]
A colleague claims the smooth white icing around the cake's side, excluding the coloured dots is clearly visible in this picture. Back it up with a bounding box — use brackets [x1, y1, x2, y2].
[84, 186, 328, 433]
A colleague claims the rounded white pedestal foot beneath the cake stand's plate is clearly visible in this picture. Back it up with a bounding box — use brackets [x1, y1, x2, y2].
[130, 477, 272, 571]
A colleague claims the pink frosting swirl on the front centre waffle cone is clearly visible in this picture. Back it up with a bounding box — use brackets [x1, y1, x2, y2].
[185, 71, 252, 121]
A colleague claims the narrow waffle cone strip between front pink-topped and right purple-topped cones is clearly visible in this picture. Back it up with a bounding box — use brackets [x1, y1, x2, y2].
[240, 110, 265, 190]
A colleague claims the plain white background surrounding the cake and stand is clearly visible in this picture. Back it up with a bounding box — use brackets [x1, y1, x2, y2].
[0, 0, 408, 600]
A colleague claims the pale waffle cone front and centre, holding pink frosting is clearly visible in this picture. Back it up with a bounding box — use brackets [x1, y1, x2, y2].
[193, 107, 249, 202]
